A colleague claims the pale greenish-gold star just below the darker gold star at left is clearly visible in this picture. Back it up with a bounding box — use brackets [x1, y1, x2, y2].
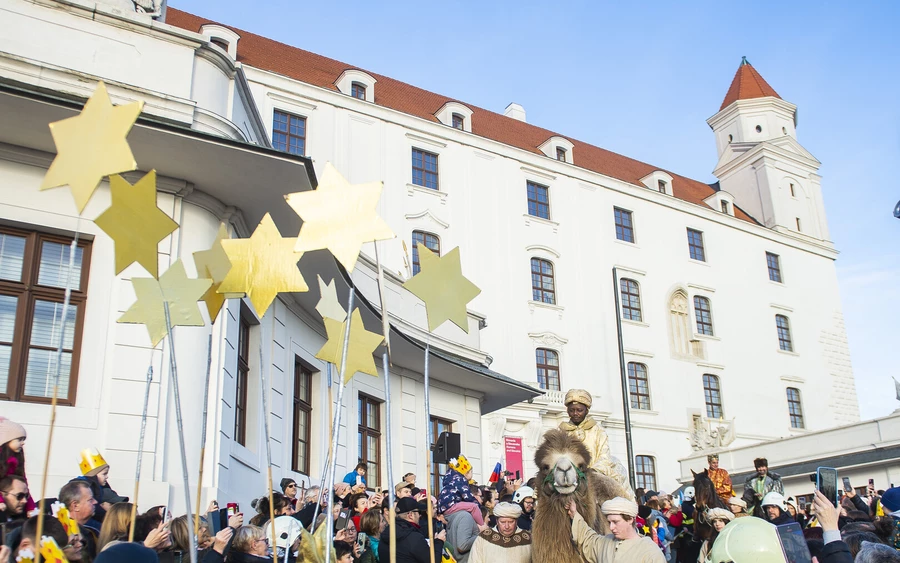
[117, 260, 212, 346]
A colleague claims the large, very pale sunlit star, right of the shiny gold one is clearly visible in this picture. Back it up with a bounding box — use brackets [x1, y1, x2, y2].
[284, 162, 394, 272]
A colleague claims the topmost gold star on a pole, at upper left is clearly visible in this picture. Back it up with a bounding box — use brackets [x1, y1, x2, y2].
[41, 81, 144, 213]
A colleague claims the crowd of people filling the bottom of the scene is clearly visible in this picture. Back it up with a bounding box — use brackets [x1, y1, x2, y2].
[0, 390, 900, 563]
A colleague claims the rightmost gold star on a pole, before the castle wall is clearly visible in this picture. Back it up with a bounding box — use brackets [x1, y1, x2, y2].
[404, 244, 481, 334]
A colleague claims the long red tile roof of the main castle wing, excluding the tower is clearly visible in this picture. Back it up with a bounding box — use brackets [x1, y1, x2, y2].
[166, 6, 756, 223]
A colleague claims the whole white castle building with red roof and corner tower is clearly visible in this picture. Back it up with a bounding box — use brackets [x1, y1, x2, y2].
[0, 0, 859, 506]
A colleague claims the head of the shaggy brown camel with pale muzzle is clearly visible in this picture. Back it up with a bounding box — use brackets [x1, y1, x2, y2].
[534, 430, 591, 495]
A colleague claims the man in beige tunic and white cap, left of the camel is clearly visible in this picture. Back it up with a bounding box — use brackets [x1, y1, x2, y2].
[469, 502, 531, 563]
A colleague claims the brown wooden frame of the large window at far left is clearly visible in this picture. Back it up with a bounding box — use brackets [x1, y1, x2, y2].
[0, 225, 93, 406]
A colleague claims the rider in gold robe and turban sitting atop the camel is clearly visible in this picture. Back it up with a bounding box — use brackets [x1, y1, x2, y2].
[559, 389, 634, 496]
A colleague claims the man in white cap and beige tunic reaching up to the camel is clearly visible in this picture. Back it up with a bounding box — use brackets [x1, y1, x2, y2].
[567, 497, 666, 563]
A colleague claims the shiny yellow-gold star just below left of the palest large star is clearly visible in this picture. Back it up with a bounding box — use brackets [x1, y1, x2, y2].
[218, 213, 309, 317]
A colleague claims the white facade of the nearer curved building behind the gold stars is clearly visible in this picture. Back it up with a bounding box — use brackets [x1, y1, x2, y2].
[0, 0, 536, 513]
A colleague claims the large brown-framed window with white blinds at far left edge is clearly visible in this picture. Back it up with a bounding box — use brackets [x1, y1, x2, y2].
[0, 227, 91, 405]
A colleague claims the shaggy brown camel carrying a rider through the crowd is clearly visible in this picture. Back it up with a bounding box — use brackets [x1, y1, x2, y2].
[531, 430, 622, 563]
